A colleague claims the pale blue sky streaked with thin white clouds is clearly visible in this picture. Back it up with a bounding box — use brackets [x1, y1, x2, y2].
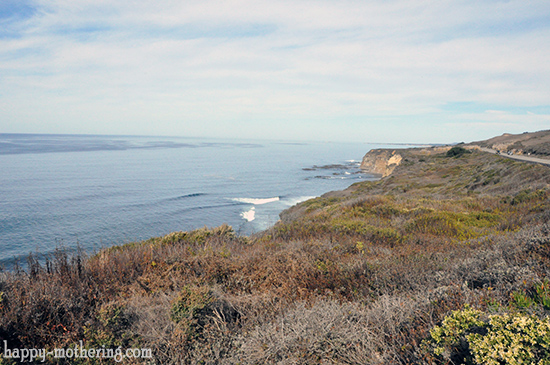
[0, 0, 550, 143]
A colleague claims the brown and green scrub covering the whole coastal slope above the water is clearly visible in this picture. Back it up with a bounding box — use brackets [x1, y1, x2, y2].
[0, 147, 550, 364]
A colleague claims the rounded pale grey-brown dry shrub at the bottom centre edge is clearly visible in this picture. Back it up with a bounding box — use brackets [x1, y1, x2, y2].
[233, 300, 386, 364]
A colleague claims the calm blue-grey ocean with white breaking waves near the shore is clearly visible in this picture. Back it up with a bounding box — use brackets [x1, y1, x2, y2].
[0, 134, 390, 268]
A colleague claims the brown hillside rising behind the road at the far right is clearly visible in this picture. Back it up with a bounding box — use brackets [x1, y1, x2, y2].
[468, 130, 550, 157]
